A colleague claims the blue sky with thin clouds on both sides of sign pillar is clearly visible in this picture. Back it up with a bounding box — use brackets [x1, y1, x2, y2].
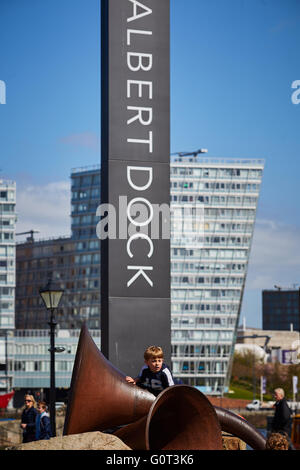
[0, 0, 300, 327]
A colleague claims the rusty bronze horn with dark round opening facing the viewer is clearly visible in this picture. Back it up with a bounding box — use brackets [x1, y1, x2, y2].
[115, 385, 223, 450]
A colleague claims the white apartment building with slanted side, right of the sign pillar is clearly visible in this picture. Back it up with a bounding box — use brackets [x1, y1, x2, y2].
[171, 157, 264, 394]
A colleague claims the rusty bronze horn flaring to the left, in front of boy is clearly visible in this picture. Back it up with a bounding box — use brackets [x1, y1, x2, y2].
[63, 325, 155, 435]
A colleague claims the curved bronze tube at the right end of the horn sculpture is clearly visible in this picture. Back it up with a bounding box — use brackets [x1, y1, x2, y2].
[215, 406, 266, 450]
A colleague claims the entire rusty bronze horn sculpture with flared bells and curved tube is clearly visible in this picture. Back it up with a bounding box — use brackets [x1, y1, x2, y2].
[63, 324, 265, 450]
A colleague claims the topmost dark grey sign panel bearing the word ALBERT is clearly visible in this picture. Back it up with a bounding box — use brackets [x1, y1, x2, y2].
[108, 0, 170, 162]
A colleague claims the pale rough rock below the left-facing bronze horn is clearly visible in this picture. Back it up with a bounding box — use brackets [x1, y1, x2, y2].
[6, 431, 131, 450]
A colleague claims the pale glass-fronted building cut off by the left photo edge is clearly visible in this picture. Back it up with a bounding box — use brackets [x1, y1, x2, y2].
[0, 179, 16, 330]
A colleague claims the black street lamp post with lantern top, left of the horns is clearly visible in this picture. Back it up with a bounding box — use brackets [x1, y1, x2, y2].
[39, 279, 64, 437]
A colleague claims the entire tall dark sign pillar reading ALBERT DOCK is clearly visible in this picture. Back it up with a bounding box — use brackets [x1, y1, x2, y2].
[98, 0, 171, 376]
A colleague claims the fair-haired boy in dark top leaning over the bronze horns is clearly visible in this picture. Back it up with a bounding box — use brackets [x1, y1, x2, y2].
[126, 346, 174, 397]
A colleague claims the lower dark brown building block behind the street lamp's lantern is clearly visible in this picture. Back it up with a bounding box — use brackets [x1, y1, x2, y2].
[16, 237, 80, 330]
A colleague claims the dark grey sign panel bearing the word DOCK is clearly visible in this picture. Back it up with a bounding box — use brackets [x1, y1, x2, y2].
[109, 161, 170, 298]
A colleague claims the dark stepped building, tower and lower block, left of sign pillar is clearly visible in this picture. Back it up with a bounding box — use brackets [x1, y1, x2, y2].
[16, 167, 100, 330]
